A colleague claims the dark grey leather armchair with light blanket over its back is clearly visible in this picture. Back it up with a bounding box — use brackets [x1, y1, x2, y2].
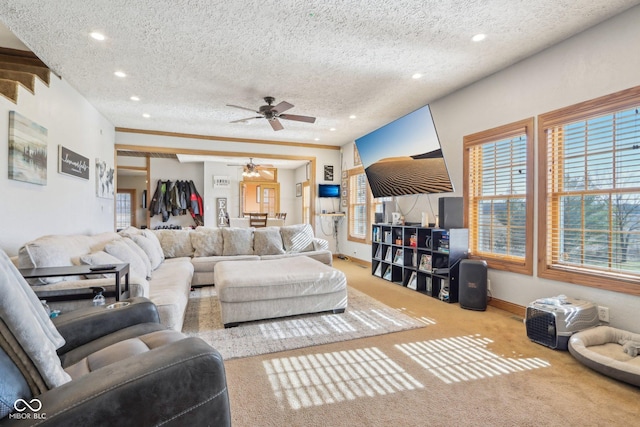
[0, 251, 231, 426]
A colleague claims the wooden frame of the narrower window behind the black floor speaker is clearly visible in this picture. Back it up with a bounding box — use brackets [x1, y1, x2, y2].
[462, 117, 535, 276]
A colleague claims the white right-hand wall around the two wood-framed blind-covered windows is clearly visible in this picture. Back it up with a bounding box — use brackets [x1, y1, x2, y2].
[343, 6, 640, 332]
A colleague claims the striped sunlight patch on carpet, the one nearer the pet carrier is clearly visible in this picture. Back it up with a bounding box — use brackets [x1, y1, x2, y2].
[395, 334, 551, 384]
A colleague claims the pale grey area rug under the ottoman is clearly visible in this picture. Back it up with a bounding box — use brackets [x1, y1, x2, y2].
[182, 286, 427, 360]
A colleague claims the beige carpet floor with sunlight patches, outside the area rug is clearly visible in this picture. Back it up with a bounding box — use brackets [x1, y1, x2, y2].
[216, 260, 640, 427]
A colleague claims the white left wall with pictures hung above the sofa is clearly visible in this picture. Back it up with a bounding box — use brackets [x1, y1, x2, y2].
[0, 75, 115, 256]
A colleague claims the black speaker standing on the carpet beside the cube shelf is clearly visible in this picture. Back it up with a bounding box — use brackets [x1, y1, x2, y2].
[458, 259, 487, 311]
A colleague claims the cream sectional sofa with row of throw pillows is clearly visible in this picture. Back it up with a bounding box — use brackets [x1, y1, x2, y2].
[13, 224, 332, 331]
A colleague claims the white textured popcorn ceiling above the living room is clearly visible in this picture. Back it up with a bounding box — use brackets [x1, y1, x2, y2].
[0, 0, 640, 145]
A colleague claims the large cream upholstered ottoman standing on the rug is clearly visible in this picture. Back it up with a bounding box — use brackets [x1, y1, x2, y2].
[214, 256, 347, 328]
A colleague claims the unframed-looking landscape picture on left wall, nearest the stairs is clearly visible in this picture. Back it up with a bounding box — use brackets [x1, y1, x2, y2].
[9, 111, 48, 185]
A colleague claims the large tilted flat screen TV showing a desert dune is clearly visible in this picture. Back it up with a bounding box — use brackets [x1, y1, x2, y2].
[356, 105, 453, 198]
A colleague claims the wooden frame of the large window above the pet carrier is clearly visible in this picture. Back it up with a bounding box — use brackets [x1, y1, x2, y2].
[538, 86, 640, 295]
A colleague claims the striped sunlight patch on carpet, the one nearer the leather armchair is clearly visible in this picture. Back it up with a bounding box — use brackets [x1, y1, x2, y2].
[263, 347, 424, 409]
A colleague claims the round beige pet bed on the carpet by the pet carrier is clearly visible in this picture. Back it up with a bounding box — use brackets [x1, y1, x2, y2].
[569, 326, 640, 387]
